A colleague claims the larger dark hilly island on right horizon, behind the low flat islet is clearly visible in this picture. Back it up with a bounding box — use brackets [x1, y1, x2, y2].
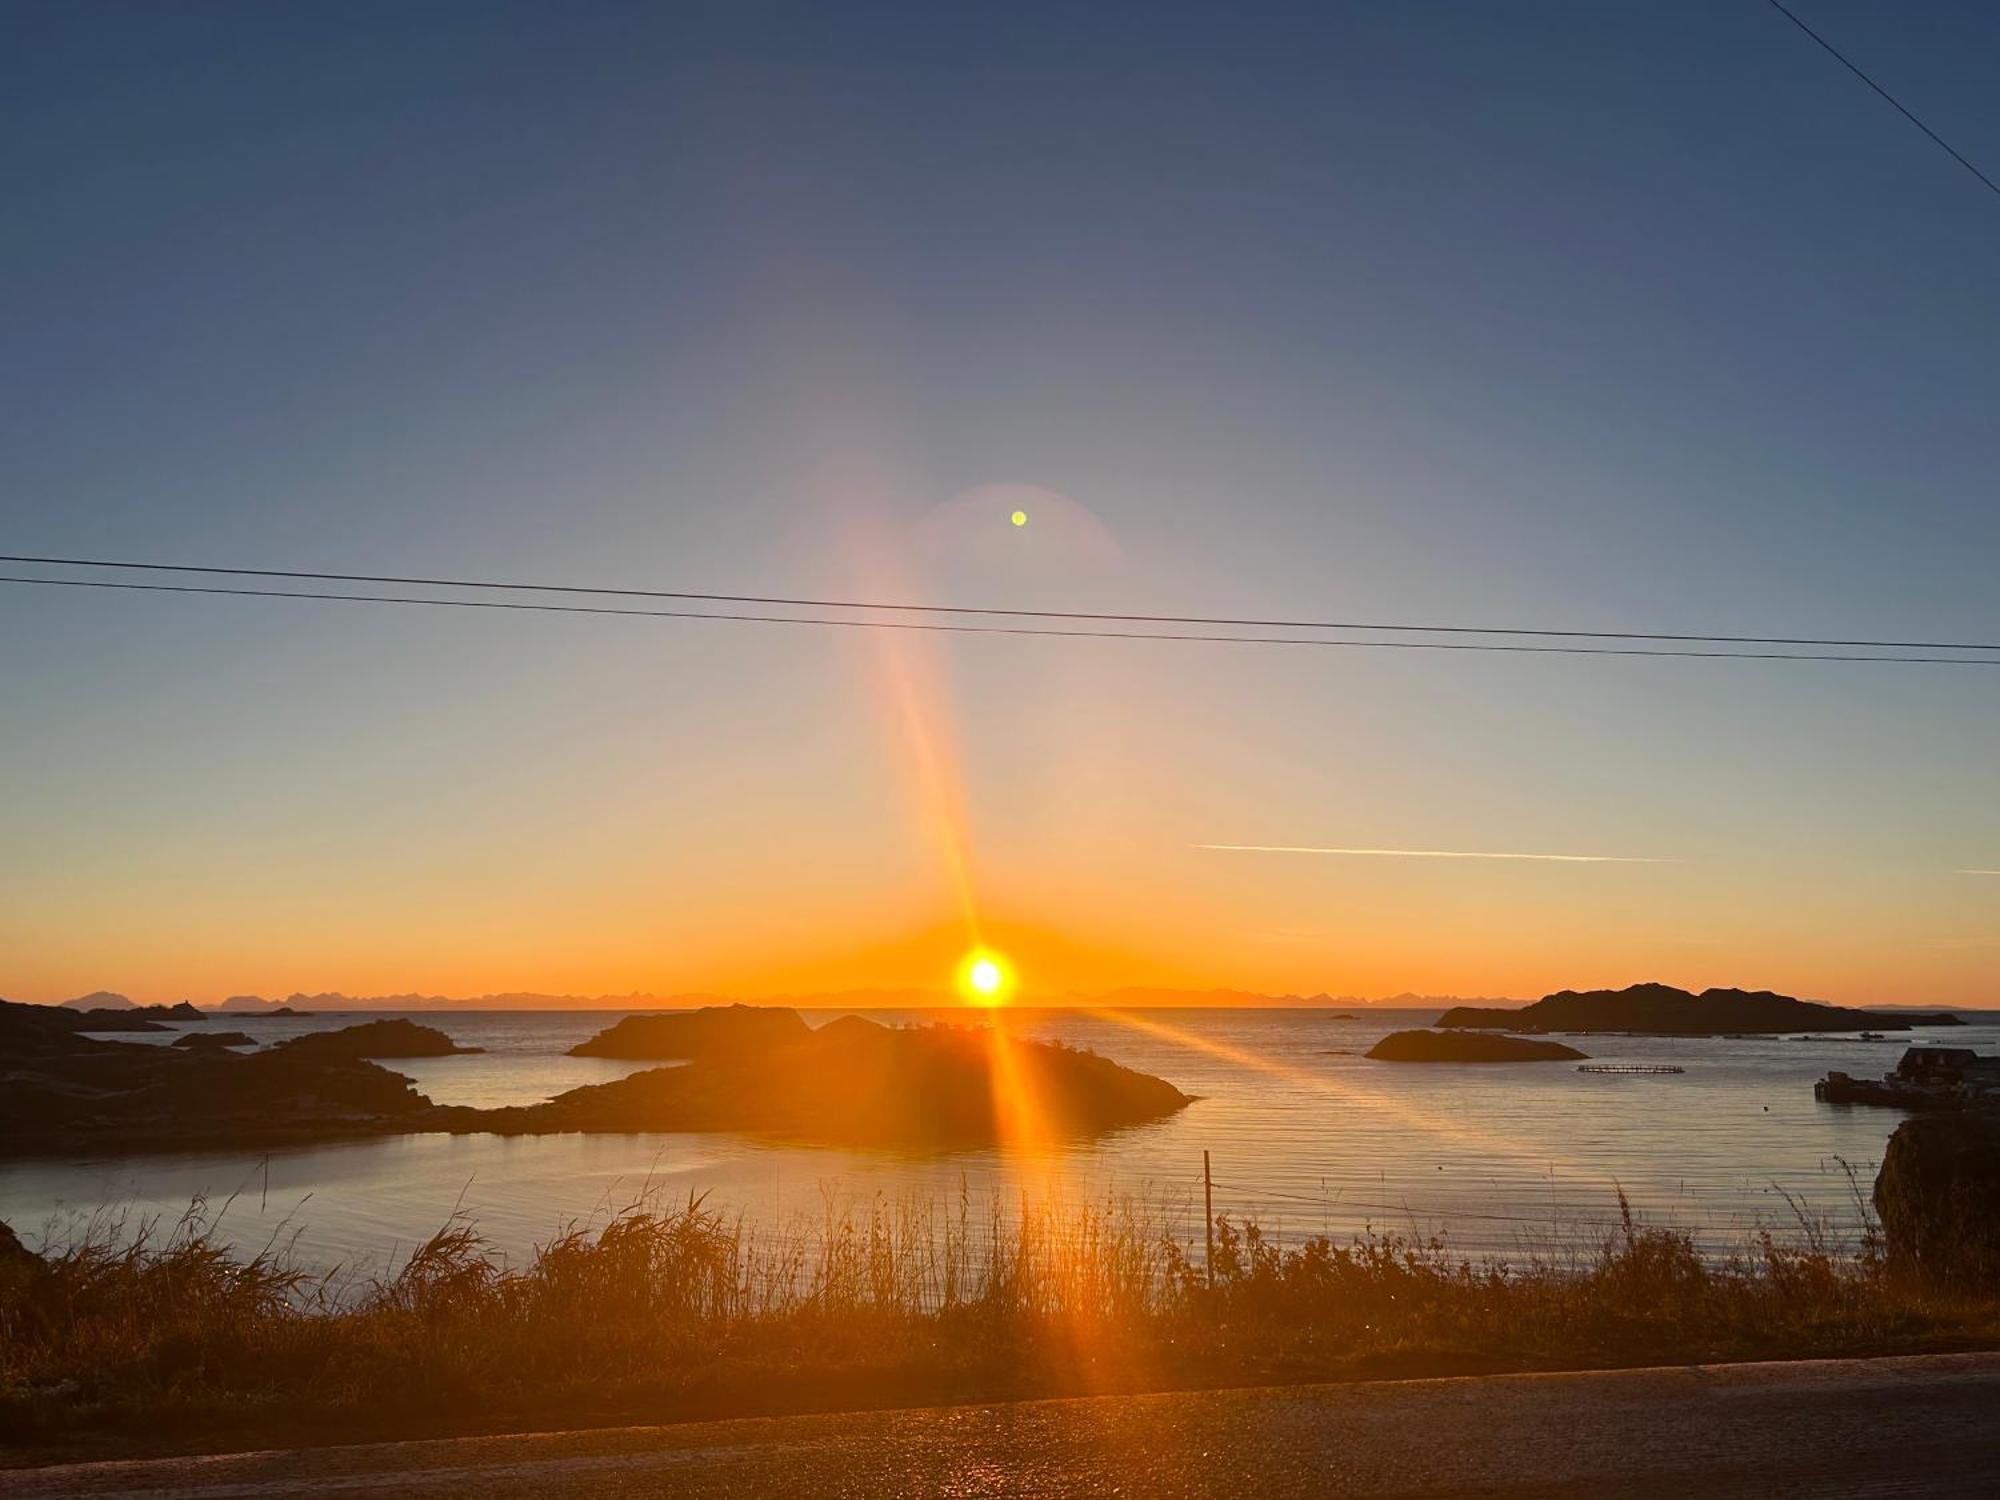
[1436, 984, 1964, 1036]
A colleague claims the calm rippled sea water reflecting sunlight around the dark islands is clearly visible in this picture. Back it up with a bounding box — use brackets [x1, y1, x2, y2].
[0, 1010, 2000, 1268]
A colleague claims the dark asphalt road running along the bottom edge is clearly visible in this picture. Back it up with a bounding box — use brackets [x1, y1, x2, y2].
[0, 1354, 2000, 1500]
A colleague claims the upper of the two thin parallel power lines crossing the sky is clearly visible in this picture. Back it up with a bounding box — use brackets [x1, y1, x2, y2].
[0, 552, 2000, 662]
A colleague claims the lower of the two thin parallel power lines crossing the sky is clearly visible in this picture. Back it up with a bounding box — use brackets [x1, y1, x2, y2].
[0, 574, 2000, 666]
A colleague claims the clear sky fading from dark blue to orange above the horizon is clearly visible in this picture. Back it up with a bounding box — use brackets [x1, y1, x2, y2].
[0, 0, 2000, 1006]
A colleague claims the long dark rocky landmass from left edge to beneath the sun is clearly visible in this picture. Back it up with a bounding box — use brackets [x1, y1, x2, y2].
[0, 1002, 1190, 1154]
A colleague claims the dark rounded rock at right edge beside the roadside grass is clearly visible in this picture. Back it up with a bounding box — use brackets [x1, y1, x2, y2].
[1874, 1112, 2000, 1288]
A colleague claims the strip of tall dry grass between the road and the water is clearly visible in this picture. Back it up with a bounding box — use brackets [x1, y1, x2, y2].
[0, 1194, 2000, 1462]
